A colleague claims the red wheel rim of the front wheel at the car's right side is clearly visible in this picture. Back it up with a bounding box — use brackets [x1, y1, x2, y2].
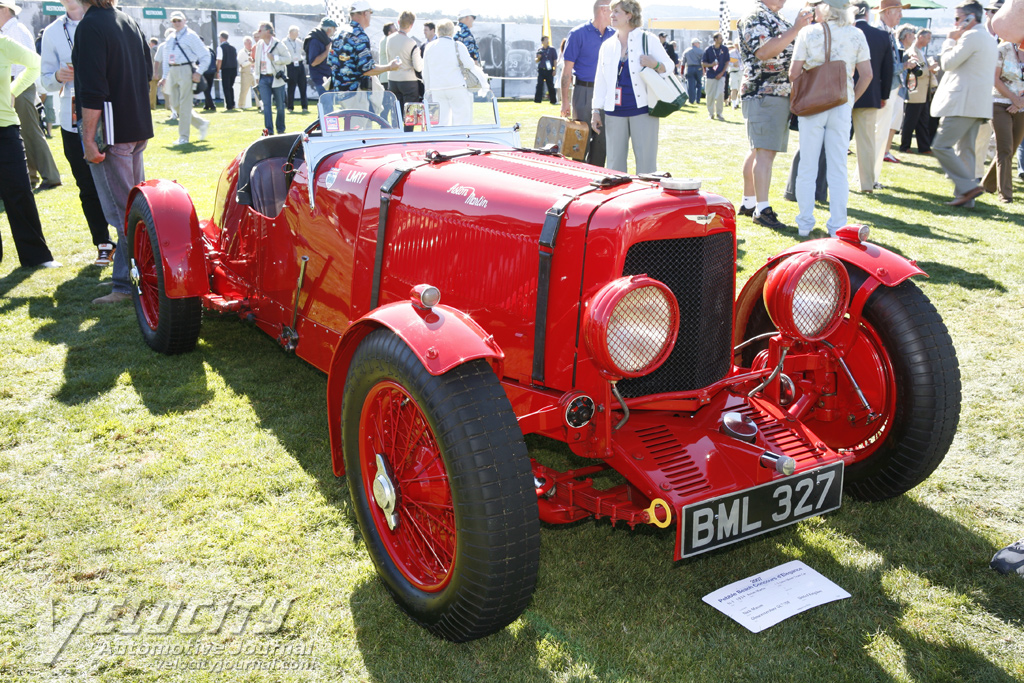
[809, 321, 896, 458]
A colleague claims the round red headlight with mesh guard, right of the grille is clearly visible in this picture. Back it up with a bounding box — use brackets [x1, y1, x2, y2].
[764, 253, 850, 341]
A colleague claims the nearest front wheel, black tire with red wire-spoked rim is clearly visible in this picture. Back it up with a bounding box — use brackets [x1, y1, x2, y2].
[341, 330, 540, 642]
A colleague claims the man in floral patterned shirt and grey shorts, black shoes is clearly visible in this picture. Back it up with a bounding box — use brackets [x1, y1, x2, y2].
[739, 0, 812, 229]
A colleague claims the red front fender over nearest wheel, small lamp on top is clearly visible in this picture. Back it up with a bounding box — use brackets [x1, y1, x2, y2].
[327, 301, 505, 476]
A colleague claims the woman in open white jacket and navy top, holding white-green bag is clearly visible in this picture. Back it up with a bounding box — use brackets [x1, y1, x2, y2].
[591, 0, 672, 173]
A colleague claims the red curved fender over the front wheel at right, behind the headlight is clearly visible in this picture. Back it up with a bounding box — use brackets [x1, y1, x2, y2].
[732, 239, 928, 346]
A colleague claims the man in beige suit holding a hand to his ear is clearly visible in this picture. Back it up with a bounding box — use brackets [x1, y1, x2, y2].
[932, 0, 996, 207]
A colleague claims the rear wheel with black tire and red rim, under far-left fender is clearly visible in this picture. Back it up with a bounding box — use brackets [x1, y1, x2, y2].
[125, 193, 203, 355]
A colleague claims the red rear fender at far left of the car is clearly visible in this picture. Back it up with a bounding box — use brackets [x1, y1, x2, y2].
[125, 180, 210, 299]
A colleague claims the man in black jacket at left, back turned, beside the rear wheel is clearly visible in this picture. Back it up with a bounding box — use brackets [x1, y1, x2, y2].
[72, 0, 153, 304]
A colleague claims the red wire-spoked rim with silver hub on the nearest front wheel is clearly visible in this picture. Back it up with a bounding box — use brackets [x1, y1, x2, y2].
[359, 381, 456, 592]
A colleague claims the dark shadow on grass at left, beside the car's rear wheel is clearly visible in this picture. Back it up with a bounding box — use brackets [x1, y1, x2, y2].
[18, 265, 213, 415]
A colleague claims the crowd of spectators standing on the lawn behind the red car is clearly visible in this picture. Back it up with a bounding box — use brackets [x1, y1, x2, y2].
[6, 0, 1024, 278]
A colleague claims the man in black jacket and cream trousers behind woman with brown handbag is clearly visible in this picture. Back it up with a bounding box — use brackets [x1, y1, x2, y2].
[853, 0, 893, 193]
